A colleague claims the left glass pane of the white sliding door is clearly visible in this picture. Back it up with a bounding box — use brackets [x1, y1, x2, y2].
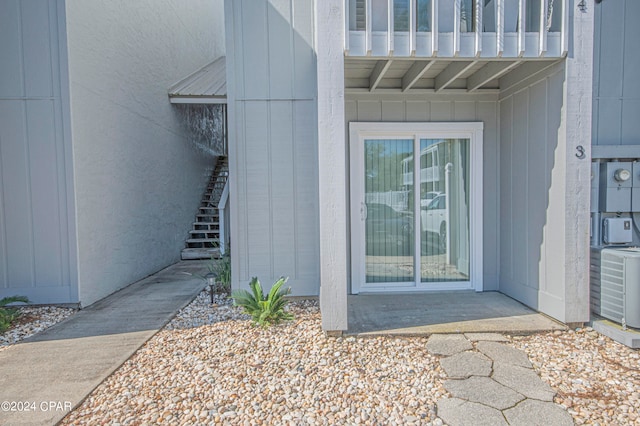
[364, 139, 415, 285]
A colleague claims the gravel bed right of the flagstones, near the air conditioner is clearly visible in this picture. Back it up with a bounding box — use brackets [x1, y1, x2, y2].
[512, 327, 640, 425]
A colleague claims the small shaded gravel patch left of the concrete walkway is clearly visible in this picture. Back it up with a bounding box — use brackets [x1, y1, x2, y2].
[0, 306, 77, 351]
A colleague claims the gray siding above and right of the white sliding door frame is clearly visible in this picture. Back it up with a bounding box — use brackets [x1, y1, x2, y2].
[345, 94, 500, 291]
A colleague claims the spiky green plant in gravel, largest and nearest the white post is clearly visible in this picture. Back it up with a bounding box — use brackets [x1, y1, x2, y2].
[231, 277, 293, 327]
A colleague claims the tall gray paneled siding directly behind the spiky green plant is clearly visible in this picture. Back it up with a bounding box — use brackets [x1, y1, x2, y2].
[225, 0, 320, 295]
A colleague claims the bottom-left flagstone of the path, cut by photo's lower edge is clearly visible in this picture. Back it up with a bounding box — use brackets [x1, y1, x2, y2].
[437, 398, 507, 426]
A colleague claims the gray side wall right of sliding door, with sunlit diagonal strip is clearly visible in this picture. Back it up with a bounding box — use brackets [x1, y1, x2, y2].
[499, 65, 567, 309]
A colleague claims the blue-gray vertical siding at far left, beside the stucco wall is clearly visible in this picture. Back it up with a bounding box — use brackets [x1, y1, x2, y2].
[0, 0, 78, 303]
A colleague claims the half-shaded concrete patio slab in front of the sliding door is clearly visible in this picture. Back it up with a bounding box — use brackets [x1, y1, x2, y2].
[347, 291, 567, 336]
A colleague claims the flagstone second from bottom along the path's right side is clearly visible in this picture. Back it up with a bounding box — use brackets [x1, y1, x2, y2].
[491, 361, 556, 401]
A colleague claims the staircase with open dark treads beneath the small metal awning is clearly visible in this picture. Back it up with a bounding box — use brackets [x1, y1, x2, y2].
[181, 157, 229, 260]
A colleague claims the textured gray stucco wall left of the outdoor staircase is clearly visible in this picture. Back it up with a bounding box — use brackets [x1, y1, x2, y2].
[66, 0, 224, 305]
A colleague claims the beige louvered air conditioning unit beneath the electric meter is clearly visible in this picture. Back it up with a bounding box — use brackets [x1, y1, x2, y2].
[591, 247, 640, 328]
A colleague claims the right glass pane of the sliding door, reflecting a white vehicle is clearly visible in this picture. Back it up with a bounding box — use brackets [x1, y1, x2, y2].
[419, 139, 470, 283]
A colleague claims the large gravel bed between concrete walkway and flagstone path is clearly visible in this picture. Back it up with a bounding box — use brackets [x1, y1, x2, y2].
[62, 293, 446, 425]
